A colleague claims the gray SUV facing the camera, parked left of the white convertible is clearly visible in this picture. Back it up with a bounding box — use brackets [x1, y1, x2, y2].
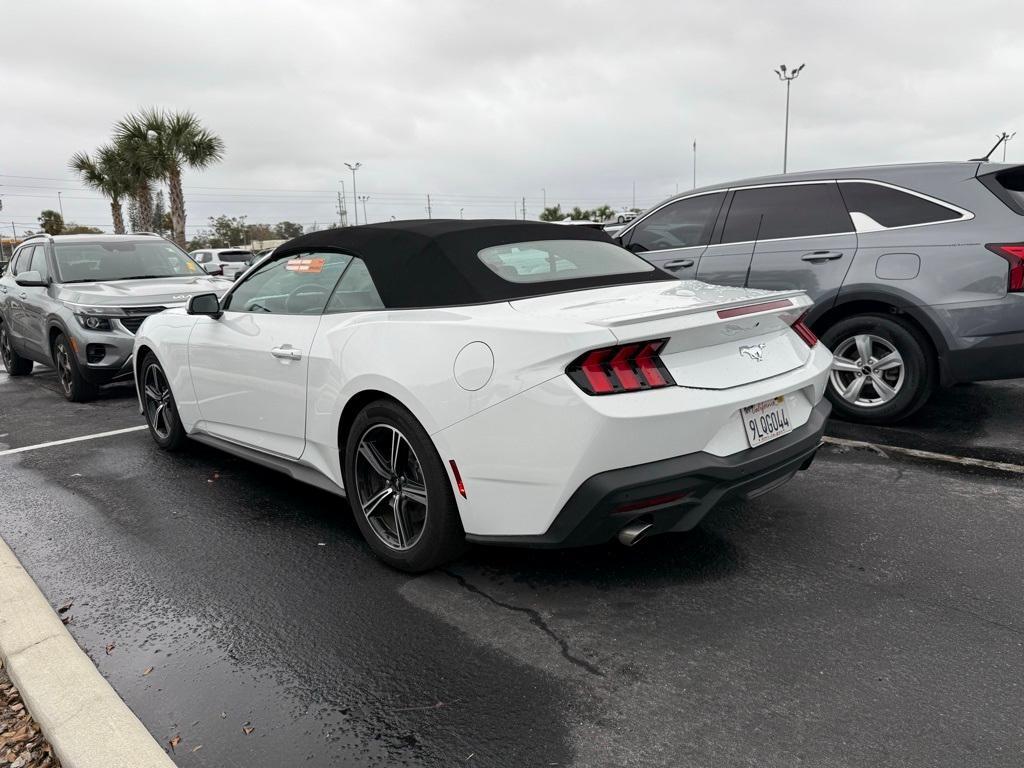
[0, 233, 231, 402]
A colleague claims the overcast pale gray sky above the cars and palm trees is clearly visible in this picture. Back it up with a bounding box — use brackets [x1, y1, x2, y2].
[0, 0, 1024, 233]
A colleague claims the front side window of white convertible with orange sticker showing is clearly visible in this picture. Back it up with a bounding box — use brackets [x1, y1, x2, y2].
[224, 253, 352, 314]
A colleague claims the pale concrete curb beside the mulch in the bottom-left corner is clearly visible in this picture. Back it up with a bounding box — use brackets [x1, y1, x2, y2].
[0, 539, 174, 768]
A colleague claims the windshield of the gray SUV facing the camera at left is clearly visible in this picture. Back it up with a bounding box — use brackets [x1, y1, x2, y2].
[53, 239, 205, 283]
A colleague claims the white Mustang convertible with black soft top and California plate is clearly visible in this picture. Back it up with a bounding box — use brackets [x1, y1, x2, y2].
[135, 220, 831, 570]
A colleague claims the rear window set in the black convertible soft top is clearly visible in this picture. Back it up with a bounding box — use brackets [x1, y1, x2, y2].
[477, 240, 655, 283]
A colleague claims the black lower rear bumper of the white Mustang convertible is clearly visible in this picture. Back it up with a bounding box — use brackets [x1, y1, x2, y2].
[466, 399, 831, 547]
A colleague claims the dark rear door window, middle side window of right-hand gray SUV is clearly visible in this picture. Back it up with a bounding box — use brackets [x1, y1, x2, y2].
[722, 182, 854, 243]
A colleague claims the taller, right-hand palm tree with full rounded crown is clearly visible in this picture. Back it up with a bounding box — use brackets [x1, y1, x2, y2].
[114, 109, 224, 248]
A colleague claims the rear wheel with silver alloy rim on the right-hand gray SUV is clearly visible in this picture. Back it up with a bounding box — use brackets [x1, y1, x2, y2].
[821, 314, 938, 424]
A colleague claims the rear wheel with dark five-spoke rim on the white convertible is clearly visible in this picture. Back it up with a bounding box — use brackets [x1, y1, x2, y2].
[344, 399, 466, 573]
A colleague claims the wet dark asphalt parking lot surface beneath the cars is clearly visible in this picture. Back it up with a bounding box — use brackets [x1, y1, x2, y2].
[0, 371, 1024, 768]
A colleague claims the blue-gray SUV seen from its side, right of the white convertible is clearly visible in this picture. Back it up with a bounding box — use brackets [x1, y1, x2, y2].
[615, 162, 1024, 424]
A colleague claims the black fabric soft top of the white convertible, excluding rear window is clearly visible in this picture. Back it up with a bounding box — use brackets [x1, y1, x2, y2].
[274, 219, 672, 309]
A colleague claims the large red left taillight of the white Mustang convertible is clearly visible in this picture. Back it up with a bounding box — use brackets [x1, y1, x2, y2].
[565, 339, 676, 394]
